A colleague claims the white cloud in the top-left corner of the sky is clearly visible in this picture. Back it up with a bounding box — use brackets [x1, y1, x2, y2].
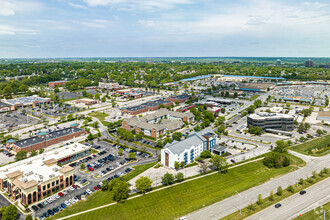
[0, 0, 43, 16]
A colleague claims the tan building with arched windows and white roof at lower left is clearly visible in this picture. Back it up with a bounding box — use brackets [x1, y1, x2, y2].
[0, 143, 91, 205]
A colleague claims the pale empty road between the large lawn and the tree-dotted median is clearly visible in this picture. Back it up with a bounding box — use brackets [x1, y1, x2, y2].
[186, 153, 330, 220]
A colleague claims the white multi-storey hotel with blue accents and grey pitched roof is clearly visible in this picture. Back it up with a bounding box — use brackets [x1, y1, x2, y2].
[161, 129, 217, 168]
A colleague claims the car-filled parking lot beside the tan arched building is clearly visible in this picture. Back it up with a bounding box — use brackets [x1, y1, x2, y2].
[32, 141, 156, 219]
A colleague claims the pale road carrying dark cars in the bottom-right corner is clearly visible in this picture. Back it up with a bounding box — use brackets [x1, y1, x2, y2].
[246, 178, 330, 220]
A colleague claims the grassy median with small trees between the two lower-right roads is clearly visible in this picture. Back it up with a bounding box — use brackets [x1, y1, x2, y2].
[222, 168, 330, 220]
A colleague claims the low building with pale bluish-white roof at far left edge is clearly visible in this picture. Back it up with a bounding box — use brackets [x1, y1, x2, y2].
[1, 95, 51, 109]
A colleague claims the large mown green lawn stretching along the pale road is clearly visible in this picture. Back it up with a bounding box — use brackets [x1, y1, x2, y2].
[56, 161, 296, 220]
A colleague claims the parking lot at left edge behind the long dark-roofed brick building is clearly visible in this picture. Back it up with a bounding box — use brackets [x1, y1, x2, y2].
[0, 111, 41, 132]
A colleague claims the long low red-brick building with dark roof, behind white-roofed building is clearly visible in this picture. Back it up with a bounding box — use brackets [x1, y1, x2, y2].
[6, 124, 87, 152]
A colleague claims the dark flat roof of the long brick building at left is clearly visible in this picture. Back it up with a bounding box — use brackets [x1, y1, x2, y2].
[15, 127, 83, 148]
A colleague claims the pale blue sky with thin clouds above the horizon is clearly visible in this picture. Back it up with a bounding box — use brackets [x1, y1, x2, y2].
[0, 0, 330, 58]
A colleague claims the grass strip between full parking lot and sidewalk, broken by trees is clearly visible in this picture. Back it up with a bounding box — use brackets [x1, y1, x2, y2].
[50, 161, 157, 219]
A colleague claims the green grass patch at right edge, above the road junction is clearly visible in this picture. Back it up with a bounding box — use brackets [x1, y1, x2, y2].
[290, 134, 330, 156]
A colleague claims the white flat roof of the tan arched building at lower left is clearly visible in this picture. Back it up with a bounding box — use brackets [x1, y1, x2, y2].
[0, 143, 90, 183]
